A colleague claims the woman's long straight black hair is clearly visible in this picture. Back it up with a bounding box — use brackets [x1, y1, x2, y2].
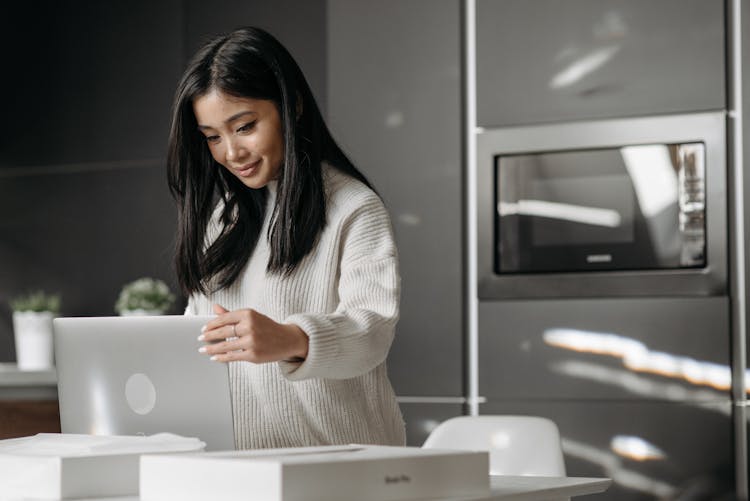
[167, 27, 371, 295]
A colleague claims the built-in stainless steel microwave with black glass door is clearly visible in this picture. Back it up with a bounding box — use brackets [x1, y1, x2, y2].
[477, 112, 727, 299]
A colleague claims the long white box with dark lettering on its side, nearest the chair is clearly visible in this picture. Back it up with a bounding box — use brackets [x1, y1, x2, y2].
[140, 445, 489, 501]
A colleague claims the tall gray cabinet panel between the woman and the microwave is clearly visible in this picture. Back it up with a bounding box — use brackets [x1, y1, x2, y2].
[327, 0, 463, 396]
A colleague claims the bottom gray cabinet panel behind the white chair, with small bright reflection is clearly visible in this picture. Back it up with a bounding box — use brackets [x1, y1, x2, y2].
[480, 400, 736, 501]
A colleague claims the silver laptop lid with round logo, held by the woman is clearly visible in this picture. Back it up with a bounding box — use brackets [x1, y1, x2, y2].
[54, 315, 234, 450]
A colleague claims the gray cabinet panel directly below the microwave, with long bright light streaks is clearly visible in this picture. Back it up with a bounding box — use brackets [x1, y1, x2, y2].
[479, 297, 731, 401]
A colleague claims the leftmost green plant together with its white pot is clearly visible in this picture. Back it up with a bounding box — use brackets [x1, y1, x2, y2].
[10, 291, 60, 371]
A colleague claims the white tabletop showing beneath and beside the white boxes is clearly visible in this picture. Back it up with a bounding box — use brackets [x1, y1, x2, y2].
[54, 475, 612, 501]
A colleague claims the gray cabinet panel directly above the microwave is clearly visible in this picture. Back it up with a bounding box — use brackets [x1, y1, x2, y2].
[476, 0, 725, 127]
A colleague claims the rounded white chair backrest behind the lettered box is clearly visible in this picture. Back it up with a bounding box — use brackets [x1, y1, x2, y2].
[422, 416, 565, 476]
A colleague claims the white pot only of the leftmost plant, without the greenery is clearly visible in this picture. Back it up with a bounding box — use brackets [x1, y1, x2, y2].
[13, 311, 55, 371]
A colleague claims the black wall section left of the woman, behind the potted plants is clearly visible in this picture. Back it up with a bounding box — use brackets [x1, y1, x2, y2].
[0, 0, 183, 361]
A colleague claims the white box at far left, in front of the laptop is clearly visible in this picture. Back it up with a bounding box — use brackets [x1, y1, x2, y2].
[0, 433, 205, 500]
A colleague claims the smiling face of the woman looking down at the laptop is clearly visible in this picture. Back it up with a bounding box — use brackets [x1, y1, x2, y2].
[193, 90, 284, 189]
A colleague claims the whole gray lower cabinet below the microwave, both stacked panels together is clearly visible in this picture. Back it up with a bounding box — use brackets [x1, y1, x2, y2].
[479, 297, 734, 500]
